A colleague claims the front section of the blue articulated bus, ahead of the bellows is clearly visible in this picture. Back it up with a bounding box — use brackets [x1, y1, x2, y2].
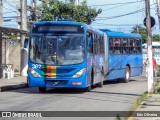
[27, 20, 107, 92]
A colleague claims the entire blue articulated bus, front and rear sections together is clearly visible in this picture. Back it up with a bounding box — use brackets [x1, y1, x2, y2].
[28, 21, 142, 92]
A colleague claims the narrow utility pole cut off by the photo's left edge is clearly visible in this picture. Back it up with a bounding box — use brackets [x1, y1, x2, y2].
[0, 0, 3, 78]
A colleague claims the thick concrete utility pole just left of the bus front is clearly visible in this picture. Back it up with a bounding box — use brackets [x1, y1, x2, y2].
[20, 0, 28, 76]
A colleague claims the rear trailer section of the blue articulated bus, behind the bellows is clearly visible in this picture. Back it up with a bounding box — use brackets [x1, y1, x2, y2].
[101, 29, 143, 83]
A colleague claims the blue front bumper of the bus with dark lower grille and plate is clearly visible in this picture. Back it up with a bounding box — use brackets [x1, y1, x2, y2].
[28, 74, 88, 88]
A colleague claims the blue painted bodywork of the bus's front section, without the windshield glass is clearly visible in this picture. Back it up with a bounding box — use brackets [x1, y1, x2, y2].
[28, 21, 104, 88]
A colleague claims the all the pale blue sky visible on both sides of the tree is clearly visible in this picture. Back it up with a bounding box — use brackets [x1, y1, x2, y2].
[3, 0, 160, 34]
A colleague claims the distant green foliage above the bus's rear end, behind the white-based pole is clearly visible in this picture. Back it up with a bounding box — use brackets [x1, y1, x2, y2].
[131, 26, 160, 43]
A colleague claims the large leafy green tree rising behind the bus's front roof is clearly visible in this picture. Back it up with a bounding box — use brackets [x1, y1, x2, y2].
[34, 0, 102, 24]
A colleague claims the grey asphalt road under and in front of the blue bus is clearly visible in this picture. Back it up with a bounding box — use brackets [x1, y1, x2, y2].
[0, 71, 147, 120]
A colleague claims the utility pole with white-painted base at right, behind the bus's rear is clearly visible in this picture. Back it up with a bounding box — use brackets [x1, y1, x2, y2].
[145, 0, 154, 92]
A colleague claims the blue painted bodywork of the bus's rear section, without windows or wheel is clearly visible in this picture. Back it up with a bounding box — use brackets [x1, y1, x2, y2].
[102, 30, 143, 80]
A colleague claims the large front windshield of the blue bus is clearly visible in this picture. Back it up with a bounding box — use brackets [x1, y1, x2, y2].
[30, 35, 85, 65]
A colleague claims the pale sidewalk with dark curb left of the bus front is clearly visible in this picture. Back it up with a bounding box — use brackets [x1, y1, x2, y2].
[0, 75, 27, 92]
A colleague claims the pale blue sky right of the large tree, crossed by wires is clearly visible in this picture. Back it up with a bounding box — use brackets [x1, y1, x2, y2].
[88, 0, 159, 34]
